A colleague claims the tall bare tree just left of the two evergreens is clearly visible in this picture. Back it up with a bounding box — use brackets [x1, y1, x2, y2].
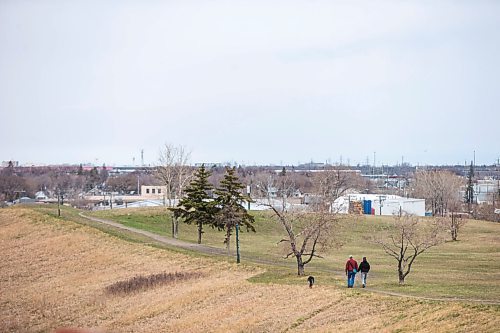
[156, 143, 192, 238]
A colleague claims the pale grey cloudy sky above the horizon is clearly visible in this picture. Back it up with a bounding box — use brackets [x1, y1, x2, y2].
[0, 0, 500, 165]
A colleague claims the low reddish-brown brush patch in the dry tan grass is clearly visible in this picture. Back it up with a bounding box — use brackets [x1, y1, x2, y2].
[106, 272, 201, 294]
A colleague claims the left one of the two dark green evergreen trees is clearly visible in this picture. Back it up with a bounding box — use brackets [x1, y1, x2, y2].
[169, 165, 217, 244]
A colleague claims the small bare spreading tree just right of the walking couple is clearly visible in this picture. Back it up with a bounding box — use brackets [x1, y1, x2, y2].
[372, 214, 442, 284]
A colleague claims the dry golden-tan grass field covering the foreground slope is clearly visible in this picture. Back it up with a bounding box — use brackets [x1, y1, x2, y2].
[0, 208, 500, 332]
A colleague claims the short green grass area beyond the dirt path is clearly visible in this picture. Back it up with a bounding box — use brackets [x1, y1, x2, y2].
[87, 208, 500, 301]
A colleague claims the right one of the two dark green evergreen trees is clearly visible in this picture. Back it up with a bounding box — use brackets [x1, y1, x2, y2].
[215, 167, 255, 253]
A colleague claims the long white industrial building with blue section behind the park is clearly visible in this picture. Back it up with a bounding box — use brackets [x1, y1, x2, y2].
[332, 194, 425, 216]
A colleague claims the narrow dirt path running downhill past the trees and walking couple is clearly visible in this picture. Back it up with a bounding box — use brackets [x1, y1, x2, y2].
[79, 212, 500, 305]
